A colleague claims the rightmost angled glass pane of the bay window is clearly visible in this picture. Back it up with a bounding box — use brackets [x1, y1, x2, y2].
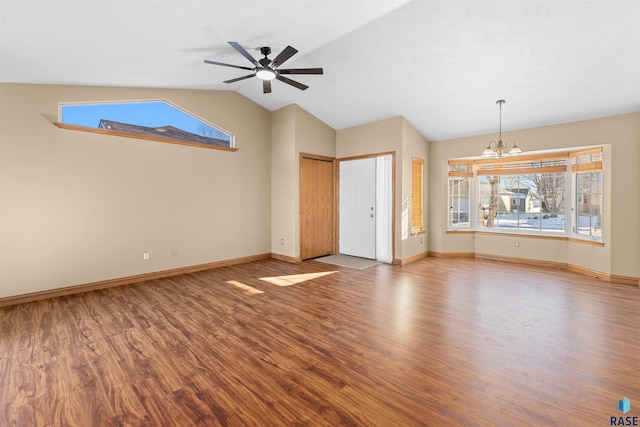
[575, 170, 602, 240]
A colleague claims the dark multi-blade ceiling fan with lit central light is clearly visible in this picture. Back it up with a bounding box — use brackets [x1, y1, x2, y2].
[204, 42, 323, 93]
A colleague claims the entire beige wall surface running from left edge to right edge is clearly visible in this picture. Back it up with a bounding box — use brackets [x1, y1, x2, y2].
[0, 84, 640, 298]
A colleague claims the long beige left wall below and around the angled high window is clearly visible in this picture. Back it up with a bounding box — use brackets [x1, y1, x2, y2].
[0, 84, 271, 297]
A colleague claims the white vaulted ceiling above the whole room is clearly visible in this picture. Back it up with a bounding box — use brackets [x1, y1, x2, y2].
[0, 0, 640, 140]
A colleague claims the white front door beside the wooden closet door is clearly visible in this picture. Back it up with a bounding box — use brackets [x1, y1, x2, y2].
[340, 157, 376, 259]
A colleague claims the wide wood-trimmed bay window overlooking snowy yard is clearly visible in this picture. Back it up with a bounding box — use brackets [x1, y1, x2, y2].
[448, 147, 603, 241]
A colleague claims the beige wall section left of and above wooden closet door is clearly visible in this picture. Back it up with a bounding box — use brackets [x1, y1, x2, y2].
[271, 104, 336, 258]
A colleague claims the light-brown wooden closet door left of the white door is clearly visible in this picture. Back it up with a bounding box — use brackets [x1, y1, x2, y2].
[300, 157, 335, 259]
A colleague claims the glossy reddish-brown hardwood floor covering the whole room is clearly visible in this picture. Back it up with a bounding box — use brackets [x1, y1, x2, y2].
[0, 258, 640, 426]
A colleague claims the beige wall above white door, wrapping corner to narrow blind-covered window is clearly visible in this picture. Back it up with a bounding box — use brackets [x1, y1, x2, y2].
[336, 116, 429, 260]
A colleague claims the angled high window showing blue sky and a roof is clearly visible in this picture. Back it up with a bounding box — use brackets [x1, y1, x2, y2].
[58, 100, 234, 149]
